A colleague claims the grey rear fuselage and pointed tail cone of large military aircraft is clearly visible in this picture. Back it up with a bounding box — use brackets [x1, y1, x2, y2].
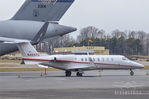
[0, 20, 76, 56]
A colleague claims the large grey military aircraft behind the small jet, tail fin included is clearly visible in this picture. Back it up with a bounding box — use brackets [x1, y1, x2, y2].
[0, 0, 76, 56]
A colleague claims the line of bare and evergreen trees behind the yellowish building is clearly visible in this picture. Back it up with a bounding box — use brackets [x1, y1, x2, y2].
[41, 26, 149, 55]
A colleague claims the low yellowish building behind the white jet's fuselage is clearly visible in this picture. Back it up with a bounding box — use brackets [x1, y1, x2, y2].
[53, 46, 109, 55]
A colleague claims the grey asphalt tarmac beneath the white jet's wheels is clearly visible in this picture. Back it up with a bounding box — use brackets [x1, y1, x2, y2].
[0, 70, 149, 99]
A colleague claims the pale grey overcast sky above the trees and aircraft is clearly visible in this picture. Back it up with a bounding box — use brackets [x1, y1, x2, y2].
[0, 0, 149, 36]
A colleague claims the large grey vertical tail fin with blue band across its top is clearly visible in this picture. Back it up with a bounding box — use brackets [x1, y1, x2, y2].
[12, 0, 74, 21]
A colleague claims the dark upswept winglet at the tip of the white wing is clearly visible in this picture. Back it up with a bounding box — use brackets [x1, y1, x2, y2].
[32, 22, 49, 44]
